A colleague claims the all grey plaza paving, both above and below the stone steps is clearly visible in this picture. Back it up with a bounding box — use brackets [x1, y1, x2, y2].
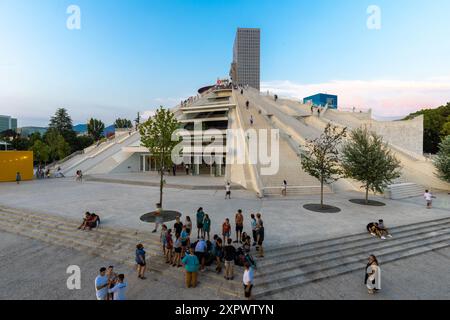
[0, 176, 450, 300]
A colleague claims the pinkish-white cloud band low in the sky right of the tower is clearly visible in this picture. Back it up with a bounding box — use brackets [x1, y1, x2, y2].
[261, 77, 450, 117]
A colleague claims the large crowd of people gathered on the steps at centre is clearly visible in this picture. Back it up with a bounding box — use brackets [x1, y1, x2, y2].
[151, 208, 264, 297]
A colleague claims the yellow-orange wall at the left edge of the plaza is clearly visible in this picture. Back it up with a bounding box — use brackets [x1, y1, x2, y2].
[0, 151, 33, 182]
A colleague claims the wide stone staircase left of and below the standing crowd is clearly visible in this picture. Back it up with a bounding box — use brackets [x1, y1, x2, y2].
[0, 207, 243, 299]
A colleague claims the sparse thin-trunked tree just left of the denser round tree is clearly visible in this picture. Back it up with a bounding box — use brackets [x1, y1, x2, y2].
[301, 124, 347, 208]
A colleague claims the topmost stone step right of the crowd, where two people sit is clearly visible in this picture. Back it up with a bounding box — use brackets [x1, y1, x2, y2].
[264, 217, 450, 257]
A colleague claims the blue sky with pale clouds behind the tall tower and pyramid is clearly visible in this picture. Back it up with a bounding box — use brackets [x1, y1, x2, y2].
[0, 0, 450, 126]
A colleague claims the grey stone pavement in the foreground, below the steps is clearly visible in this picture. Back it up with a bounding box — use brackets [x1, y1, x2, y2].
[0, 232, 450, 300]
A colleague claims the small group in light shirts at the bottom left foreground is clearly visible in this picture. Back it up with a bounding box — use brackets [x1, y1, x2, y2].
[95, 266, 128, 300]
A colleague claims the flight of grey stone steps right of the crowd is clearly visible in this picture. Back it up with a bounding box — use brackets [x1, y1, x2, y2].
[254, 217, 450, 299]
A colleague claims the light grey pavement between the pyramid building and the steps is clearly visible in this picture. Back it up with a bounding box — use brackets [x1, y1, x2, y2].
[0, 179, 450, 246]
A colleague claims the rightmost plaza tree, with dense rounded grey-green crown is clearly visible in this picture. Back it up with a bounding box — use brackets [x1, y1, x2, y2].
[341, 128, 401, 204]
